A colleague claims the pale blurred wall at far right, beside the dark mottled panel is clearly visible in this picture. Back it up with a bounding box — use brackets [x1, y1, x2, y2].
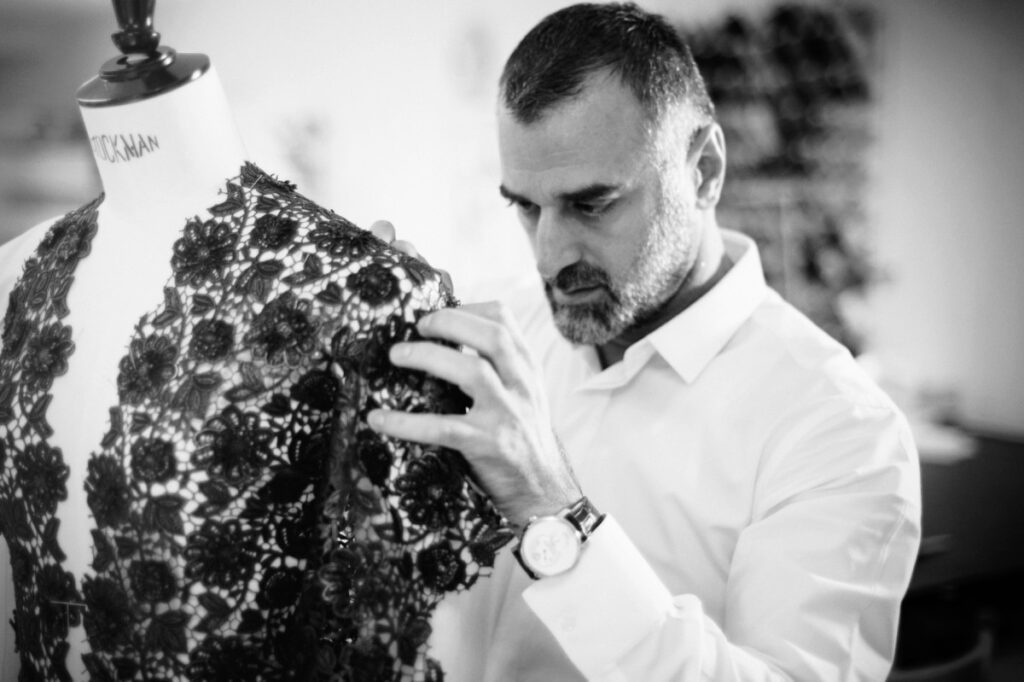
[867, 0, 1024, 435]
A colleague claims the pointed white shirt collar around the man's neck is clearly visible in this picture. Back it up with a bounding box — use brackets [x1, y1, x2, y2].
[586, 229, 768, 388]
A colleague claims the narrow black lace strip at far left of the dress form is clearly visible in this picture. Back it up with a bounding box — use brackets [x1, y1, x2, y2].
[0, 197, 102, 680]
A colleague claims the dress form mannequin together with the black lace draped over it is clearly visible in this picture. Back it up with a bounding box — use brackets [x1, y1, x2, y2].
[0, 0, 511, 682]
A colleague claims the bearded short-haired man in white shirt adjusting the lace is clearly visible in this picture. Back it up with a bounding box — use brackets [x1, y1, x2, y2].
[370, 4, 920, 681]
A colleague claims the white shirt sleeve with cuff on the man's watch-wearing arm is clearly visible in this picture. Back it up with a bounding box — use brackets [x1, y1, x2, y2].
[523, 395, 921, 682]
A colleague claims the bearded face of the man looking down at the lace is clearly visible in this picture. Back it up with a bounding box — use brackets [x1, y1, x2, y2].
[498, 77, 696, 344]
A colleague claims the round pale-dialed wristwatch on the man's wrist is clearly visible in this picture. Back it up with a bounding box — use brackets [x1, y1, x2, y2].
[512, 498, 604, 581]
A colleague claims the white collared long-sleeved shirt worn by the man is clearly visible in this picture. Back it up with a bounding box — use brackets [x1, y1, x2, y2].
[432, 230, 921, 682]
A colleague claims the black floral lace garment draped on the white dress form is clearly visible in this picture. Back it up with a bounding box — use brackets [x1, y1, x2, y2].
[0, 164, 511, 682]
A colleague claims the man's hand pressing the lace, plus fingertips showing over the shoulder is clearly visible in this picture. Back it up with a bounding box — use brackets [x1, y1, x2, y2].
[369, 221, 583, 526]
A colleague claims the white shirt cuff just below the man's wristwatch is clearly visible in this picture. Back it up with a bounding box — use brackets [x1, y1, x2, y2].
[522, 516, 673, 677]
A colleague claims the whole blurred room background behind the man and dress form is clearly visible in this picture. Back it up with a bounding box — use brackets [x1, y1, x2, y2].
[0, 0, 1024, 680]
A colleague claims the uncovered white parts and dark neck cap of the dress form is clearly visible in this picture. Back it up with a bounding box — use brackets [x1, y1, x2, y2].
[0, 2, 246, 679]
